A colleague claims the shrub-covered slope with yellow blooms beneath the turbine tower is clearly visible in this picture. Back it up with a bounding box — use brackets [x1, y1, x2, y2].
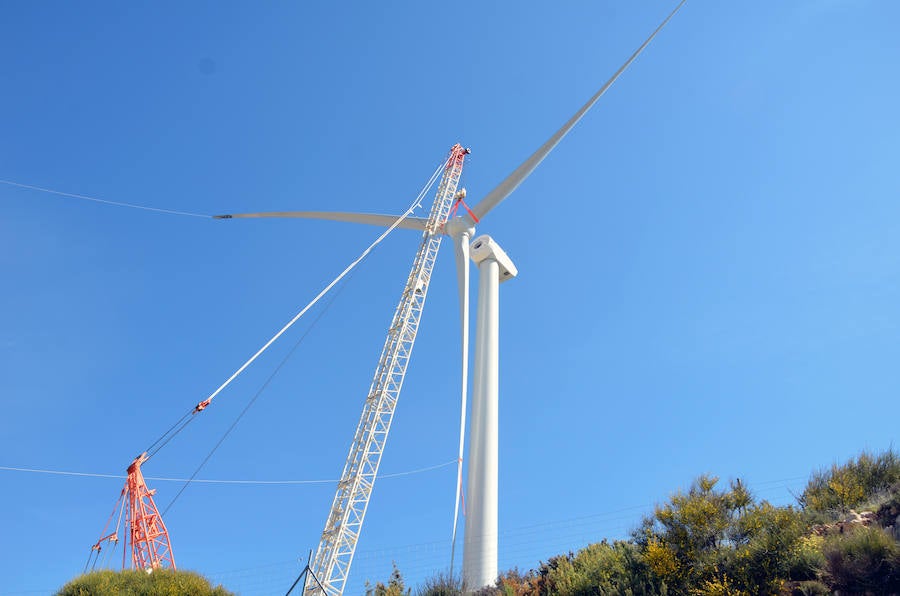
[368, 450, 900, 596]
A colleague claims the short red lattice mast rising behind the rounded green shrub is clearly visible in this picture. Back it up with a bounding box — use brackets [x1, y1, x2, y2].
[89, 453, 175, 570]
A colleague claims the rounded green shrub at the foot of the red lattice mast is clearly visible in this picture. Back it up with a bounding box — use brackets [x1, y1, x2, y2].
[56, 569, 232, 596]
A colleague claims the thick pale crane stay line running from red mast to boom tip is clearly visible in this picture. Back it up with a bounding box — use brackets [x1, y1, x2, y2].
[145, 160, 447, 461]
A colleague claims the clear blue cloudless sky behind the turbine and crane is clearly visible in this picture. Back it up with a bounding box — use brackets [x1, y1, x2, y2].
[0, 0, 900, 594]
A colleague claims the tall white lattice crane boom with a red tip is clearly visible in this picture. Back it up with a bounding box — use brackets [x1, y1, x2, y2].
[306, 144, 468, 596]
